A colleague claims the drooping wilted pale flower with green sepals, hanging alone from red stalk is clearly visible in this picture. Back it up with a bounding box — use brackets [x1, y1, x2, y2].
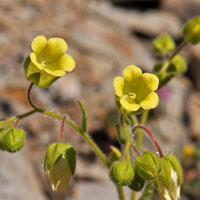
[44, 143, 76, 191]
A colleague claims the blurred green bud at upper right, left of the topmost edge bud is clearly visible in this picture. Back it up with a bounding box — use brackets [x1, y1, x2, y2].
[153, 33, 176, 55]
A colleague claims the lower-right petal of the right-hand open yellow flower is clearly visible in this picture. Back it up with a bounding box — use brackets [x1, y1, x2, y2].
[140, 92, 159, 110]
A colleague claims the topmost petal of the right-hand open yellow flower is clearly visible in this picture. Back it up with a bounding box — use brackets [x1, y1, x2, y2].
[123, 65, 142, 82]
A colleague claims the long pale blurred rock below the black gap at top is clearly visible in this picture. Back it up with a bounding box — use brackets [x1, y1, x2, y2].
[91, 2, 181, 37]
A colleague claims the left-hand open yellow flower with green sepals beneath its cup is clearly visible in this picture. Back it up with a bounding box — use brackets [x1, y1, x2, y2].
[24, 35, 75, 87]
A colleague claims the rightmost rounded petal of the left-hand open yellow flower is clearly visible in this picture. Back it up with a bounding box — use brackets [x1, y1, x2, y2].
[58, 54, 75, 72]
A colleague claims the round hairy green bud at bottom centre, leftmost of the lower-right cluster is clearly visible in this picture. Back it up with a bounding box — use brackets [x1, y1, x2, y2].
[110, 159, 134, 186]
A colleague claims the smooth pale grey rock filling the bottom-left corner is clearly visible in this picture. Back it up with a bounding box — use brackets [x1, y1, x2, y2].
[0, 148, 45, 200]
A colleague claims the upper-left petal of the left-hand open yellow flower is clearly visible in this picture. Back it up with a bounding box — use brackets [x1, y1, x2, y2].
[31, 35, 47, 54]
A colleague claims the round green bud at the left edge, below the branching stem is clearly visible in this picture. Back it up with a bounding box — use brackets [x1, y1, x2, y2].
[0, 127, 25, 152]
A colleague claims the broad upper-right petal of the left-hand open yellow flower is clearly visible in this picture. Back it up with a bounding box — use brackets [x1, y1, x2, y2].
[47, 38, 68, 56]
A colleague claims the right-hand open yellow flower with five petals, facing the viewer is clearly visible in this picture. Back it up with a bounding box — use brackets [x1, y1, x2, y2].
[113, 65, 159, 112]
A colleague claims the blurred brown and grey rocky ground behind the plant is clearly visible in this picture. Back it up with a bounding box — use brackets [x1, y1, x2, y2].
[0, 0, 200, 200]
